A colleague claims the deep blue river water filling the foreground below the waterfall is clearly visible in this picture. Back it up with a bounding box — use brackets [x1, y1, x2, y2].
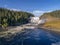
[0, 28, 60, 45]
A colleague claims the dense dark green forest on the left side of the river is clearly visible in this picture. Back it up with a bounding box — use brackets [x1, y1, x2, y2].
[0, 8, 34, 27]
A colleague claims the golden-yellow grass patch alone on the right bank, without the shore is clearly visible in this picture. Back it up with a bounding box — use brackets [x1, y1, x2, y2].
[44, 20, 60, 29]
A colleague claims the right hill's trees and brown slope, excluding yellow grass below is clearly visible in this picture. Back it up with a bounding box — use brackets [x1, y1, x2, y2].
[40, 10, 60, 21]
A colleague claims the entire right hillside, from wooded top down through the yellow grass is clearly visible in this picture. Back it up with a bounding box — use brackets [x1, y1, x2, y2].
[40, 10, 60, 32]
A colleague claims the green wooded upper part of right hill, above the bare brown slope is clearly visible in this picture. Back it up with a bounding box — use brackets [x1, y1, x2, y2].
[40, 10, 60, 18]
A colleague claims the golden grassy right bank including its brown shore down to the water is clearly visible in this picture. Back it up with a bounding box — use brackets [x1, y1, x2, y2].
[38, 20, 60, 36]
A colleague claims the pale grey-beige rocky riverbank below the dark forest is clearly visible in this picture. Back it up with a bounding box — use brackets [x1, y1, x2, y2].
[0, 24, 35, 37]
